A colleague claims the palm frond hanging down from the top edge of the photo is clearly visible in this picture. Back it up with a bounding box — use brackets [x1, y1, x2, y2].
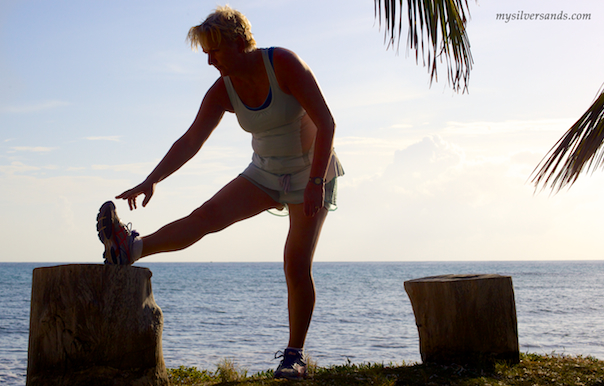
[374, 0, 473, 92]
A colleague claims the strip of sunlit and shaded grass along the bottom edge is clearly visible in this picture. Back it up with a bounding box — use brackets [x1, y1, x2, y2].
[168, 354, 604, 386]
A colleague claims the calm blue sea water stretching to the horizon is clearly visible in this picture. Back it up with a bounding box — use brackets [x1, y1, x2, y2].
[0, 261, 604, 385]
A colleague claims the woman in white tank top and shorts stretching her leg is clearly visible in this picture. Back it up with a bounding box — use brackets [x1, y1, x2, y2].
[97, 6, 344, 379]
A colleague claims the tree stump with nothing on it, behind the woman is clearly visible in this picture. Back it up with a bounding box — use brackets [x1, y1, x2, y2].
[405, 275, 520, 365]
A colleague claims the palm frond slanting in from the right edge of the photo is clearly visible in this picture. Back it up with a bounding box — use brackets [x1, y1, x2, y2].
[531, 89, 604, 192]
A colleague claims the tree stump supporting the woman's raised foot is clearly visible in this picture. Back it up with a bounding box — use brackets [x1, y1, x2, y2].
[27, 264, 169, 386]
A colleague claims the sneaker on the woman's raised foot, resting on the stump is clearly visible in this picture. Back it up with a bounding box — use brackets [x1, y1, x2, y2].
[96, 201, 139, 265]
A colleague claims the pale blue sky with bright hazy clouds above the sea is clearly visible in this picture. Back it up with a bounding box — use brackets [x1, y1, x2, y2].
[0, 0, 604, 263]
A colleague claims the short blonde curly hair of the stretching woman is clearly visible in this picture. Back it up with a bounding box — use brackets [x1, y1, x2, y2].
[187, 5, 256, 52]
